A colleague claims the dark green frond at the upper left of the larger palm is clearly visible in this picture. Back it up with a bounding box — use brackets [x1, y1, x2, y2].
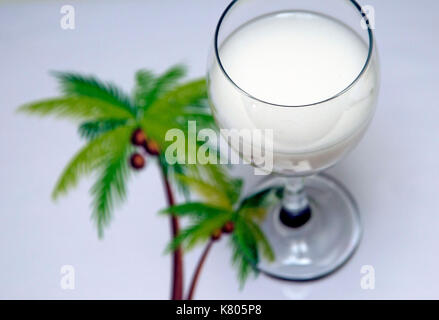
[53, 72, 135, 115]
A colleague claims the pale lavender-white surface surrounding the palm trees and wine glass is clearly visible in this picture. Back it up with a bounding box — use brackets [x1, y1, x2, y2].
[0, 0, 439, 299]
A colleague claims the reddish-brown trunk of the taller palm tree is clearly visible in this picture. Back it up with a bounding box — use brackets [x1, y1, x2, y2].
[160, 165, 183, 300]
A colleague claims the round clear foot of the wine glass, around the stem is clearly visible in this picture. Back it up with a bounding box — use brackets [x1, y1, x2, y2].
[257, 174, 361, 281]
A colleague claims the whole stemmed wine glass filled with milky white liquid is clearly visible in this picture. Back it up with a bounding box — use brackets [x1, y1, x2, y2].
[208, 0, 379, 281]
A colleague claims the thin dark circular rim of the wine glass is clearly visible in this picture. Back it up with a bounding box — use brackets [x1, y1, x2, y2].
[214, 0, 374, 108]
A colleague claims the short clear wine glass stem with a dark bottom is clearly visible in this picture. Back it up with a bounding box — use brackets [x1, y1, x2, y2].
[280, 178, 311, 228]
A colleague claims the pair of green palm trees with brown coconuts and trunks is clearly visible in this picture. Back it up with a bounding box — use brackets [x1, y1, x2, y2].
[19, 65, 273, 299]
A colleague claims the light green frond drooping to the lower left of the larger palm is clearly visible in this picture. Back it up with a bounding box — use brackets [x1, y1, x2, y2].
[52, 127, 133, 199]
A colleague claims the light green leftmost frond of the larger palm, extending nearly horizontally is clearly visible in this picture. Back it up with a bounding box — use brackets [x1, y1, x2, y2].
[18, 96, 133, 120]
